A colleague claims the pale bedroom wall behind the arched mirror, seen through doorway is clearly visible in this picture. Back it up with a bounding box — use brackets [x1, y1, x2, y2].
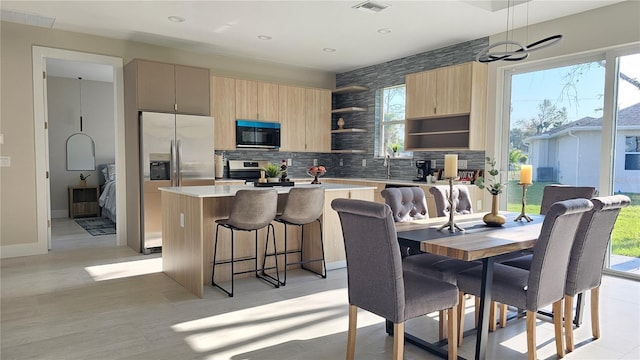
[47, 76, 116, 218]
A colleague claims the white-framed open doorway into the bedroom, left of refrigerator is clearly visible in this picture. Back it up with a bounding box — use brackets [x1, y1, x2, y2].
[33, 46, 126, 250]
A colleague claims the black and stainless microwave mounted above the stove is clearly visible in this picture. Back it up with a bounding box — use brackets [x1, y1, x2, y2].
[236, 120, 280, 149]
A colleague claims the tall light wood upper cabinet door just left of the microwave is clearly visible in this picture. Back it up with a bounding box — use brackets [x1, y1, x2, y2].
[211, 76, 236, 150]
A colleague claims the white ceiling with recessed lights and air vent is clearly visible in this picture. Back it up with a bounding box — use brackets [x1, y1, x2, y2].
[0, 0, 622, 73]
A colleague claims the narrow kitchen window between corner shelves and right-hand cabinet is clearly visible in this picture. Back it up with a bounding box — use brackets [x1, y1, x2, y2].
[378, 84, 412, 156]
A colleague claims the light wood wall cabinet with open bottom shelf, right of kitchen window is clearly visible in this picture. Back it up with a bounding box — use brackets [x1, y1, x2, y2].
[405, 62, 487, 151]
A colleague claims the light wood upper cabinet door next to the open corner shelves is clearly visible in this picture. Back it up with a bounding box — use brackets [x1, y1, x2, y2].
[303, 88, 331, 152]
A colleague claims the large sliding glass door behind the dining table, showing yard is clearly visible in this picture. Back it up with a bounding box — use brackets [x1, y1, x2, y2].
[502, 48, 640, 277]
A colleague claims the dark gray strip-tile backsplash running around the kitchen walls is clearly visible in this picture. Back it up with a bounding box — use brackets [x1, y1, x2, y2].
[216, 37, 489, 180]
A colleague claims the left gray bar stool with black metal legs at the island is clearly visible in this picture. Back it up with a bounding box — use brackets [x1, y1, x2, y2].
[211, 189, 280, 297]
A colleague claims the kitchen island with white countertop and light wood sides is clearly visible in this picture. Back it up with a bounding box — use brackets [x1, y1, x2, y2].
[160, 184, 374, 297]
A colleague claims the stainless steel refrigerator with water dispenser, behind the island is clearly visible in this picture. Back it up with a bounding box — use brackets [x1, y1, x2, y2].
[139, 112, 215, 253]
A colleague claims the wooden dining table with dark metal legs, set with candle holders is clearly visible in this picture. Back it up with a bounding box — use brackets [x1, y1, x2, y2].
[396, 213, 544, 359]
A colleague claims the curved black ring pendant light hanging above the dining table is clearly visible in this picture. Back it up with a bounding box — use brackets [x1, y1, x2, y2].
[476, 0, 562, 63]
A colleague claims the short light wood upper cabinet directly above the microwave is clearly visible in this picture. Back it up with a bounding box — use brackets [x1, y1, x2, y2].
[236, 79, 278, 122]
